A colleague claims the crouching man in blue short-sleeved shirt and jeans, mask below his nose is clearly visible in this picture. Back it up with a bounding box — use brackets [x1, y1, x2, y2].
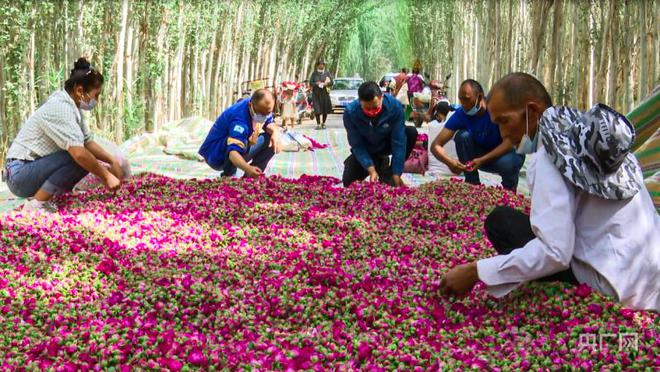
[431, 79, 525, 191]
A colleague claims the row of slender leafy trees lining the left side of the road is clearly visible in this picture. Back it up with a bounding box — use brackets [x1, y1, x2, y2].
[0, 0, 376, 155]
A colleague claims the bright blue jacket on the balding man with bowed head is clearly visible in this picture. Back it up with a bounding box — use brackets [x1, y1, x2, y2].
[199, 98, 273, 169]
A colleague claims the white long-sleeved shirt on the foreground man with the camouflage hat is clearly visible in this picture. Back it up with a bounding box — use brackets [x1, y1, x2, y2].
[477, 141, 660, 311]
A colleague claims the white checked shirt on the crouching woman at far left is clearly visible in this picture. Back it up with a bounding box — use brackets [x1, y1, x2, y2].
[7, 89, 92, 161]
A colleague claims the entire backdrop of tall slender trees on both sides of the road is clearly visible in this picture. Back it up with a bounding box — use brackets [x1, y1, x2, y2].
[0, 0, 660, 153]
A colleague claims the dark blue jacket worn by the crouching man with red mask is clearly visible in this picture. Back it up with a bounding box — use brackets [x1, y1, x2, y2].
[344, 94, 406, 175]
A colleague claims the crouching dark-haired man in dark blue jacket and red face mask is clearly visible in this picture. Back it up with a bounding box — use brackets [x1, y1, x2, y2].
[342, 81, 417, 186]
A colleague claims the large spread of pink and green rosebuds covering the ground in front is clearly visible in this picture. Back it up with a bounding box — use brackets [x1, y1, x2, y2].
[0, 175, 660, 371]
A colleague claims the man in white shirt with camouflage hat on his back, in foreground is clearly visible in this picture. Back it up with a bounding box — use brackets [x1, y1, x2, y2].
[441, 73, 660, 311]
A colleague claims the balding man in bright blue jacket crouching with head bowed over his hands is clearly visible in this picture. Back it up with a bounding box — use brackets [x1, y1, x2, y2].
[199, 89, 280, 178]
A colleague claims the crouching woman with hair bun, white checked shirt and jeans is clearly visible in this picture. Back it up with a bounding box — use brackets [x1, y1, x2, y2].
[3, 58, 123, 212]
